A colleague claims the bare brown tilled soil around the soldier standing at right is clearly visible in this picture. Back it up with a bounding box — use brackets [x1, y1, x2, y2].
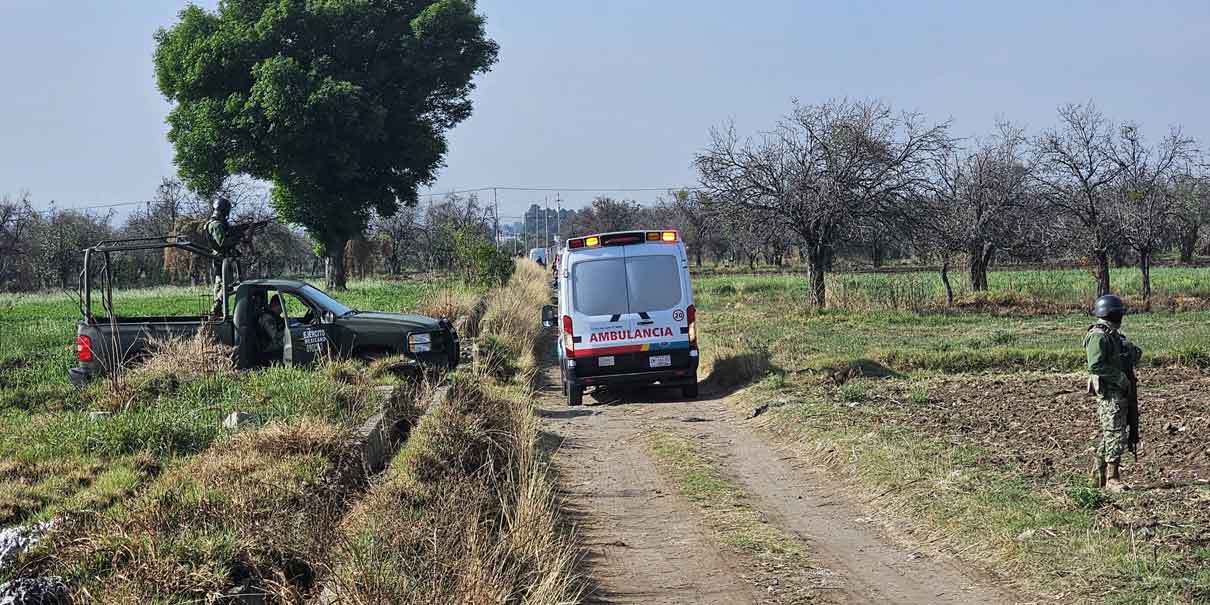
[875, 369, 1210, 555]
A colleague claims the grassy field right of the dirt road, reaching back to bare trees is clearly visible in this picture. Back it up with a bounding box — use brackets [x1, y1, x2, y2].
[696, 270, 1210, 604]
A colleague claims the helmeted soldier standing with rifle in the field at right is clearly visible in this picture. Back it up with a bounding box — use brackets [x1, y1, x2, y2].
[1084, 294, 1142, 492]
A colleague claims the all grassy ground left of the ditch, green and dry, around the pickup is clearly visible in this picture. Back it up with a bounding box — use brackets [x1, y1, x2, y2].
[0, 278, 486, 603]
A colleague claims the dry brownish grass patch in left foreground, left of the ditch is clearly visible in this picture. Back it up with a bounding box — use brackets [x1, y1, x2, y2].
[36, 420, 357, 603]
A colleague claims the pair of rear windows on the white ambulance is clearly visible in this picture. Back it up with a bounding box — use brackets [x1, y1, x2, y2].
[571, 254, 681, 315]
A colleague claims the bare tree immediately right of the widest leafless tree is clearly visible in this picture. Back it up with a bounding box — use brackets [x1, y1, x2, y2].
[918, 122, 1039, 292]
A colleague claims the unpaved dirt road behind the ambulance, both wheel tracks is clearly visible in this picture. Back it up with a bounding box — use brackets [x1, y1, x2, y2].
[541, 363, 1018, 604]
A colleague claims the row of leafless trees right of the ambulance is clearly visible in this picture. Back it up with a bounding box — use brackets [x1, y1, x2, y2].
[687, 100, 1210, 305]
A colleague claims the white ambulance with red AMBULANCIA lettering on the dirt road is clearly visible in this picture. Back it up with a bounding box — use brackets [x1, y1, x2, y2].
[542, 230, 698, 405]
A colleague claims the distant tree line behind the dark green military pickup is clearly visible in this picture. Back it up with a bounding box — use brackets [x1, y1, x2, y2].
[0, 179, 511, 292]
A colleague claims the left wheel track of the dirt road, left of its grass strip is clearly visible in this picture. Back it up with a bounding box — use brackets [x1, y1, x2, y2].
[538, 370, 757, 604]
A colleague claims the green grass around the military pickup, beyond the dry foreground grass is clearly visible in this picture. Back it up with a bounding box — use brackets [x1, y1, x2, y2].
[0, 280, 451, 526]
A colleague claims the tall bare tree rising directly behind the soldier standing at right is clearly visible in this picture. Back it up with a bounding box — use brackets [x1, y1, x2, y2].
[1031, 103, 1127, 296]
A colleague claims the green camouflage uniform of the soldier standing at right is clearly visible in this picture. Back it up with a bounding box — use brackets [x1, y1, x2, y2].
[1084, 319, 1142, 463]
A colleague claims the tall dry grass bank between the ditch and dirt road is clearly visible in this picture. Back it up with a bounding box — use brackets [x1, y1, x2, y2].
[317, 261, 580, 604]
